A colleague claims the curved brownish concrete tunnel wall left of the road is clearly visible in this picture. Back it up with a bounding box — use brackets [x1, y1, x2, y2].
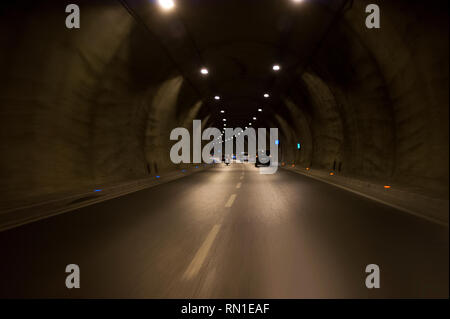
[0, 1, 202, 208]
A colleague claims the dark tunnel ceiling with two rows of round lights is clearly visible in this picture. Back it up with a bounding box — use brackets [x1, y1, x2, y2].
[126, 0, 350, 128]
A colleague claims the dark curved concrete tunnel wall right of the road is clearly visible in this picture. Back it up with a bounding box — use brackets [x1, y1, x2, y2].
[284, 1, 448, 198]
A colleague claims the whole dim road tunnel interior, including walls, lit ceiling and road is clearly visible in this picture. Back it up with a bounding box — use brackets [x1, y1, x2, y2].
[0, 0, 449, 298]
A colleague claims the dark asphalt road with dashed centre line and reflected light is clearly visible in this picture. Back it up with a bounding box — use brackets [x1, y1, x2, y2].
[0, 164, 449, 298]
